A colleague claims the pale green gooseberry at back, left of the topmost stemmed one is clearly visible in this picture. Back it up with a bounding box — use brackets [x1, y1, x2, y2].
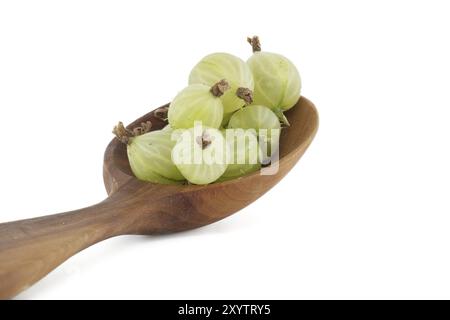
[189, 53, 254, 113]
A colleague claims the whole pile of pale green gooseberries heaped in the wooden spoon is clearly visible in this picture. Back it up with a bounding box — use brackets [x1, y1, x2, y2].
[113, 36, 301, 185]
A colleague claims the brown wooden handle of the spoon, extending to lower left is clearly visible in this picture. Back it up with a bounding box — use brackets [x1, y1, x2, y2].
[0, 198, 126, 299]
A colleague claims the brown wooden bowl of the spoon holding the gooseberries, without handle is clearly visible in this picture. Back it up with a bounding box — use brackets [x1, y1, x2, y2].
[104, 97, 318, 234]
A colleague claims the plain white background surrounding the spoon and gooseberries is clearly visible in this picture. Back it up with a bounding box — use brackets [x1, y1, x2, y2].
[0, 0, 450, 299]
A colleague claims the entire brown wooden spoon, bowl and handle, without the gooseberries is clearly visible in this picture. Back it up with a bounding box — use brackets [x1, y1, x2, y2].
[0, 97, 318, 299]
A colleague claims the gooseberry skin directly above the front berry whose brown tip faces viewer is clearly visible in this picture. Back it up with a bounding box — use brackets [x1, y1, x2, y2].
[168, 84, 223, 129]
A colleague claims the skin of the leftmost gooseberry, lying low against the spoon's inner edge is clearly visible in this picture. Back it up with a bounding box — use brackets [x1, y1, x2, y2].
[127, 130, 185, 184]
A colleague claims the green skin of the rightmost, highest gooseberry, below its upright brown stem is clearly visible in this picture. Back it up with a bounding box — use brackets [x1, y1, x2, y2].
[247, 51, 302, 111]
